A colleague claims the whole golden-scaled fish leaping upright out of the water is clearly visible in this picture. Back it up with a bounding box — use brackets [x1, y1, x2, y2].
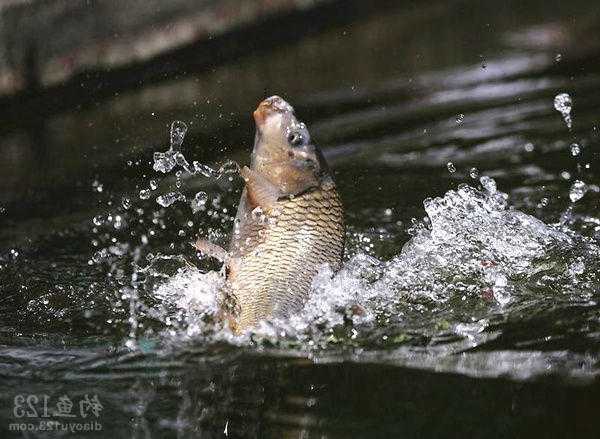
[195, 96, 345, 333]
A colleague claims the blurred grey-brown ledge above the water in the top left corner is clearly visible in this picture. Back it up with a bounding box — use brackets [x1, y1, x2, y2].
[0, 0, 330, 96]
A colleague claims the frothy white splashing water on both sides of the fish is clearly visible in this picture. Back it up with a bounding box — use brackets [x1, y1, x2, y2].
[150, 176, 584, 346]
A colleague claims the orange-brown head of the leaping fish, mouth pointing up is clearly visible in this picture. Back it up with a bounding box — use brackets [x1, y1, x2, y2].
[252, 96, 329, 194]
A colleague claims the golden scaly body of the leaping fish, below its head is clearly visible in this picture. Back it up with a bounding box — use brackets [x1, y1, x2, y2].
[229, 188, 344, 329]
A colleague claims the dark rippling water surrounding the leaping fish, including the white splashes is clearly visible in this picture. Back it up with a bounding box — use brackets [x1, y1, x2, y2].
[0, 1, 600, 438]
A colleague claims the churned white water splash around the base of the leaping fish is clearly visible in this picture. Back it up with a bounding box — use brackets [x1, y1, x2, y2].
[142, 176, 594, 356]
